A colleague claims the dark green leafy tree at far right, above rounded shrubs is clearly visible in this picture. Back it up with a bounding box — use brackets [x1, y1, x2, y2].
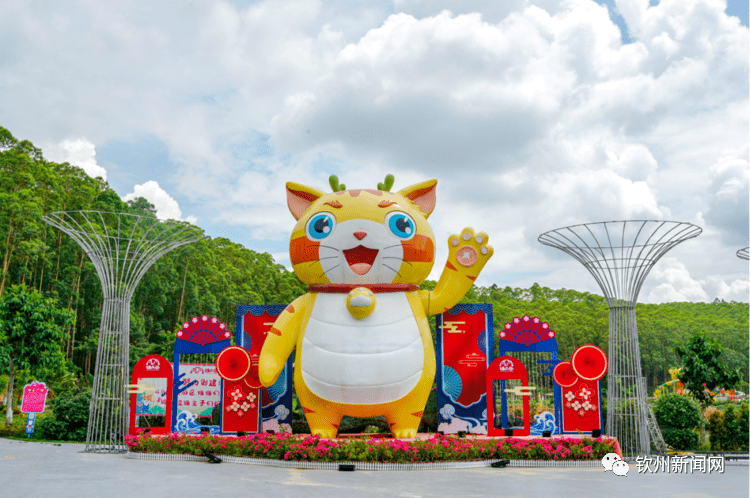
[675, 332, 742, 409]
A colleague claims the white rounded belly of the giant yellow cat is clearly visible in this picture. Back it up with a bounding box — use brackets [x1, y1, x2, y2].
[300, 292, 424, 405]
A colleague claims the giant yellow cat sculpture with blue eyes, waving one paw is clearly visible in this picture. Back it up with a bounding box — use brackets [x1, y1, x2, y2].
[259, 175, 492, 438]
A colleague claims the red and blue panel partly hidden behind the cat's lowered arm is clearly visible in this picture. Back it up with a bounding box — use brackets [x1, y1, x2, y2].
[236, 304, 294, 432]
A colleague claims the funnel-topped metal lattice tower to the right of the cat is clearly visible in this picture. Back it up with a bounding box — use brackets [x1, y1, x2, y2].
[538, 220, 702, 455]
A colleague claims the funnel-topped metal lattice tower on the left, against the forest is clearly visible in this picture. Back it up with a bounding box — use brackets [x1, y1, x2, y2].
[44, 211, 202, 453]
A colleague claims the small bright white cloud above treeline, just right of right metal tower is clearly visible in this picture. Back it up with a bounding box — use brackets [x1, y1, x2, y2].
[648, 257, 710, 304]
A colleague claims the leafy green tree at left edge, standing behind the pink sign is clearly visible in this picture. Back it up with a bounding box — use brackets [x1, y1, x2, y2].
[0, 285, 74, 425]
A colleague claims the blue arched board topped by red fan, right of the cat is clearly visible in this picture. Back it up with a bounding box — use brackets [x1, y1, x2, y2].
[498, 315, 562, 436]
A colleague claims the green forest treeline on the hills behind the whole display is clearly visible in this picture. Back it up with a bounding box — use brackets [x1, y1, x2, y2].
[0, 127, 750, 396]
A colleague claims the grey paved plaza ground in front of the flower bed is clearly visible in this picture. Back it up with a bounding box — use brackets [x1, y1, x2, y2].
[0, 439, 750, 498]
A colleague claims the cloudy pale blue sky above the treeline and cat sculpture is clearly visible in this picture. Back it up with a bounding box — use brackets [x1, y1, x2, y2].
[0, 0, 750, 302]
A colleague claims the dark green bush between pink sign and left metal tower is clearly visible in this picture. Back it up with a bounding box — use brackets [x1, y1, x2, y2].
[37, 390, 91, 441]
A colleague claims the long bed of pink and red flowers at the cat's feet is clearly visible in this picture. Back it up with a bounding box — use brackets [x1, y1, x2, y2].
[125, 433, 617, 463]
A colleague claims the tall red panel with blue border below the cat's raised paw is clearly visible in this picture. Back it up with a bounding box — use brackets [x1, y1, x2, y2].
[436, 304, 495, 434]
